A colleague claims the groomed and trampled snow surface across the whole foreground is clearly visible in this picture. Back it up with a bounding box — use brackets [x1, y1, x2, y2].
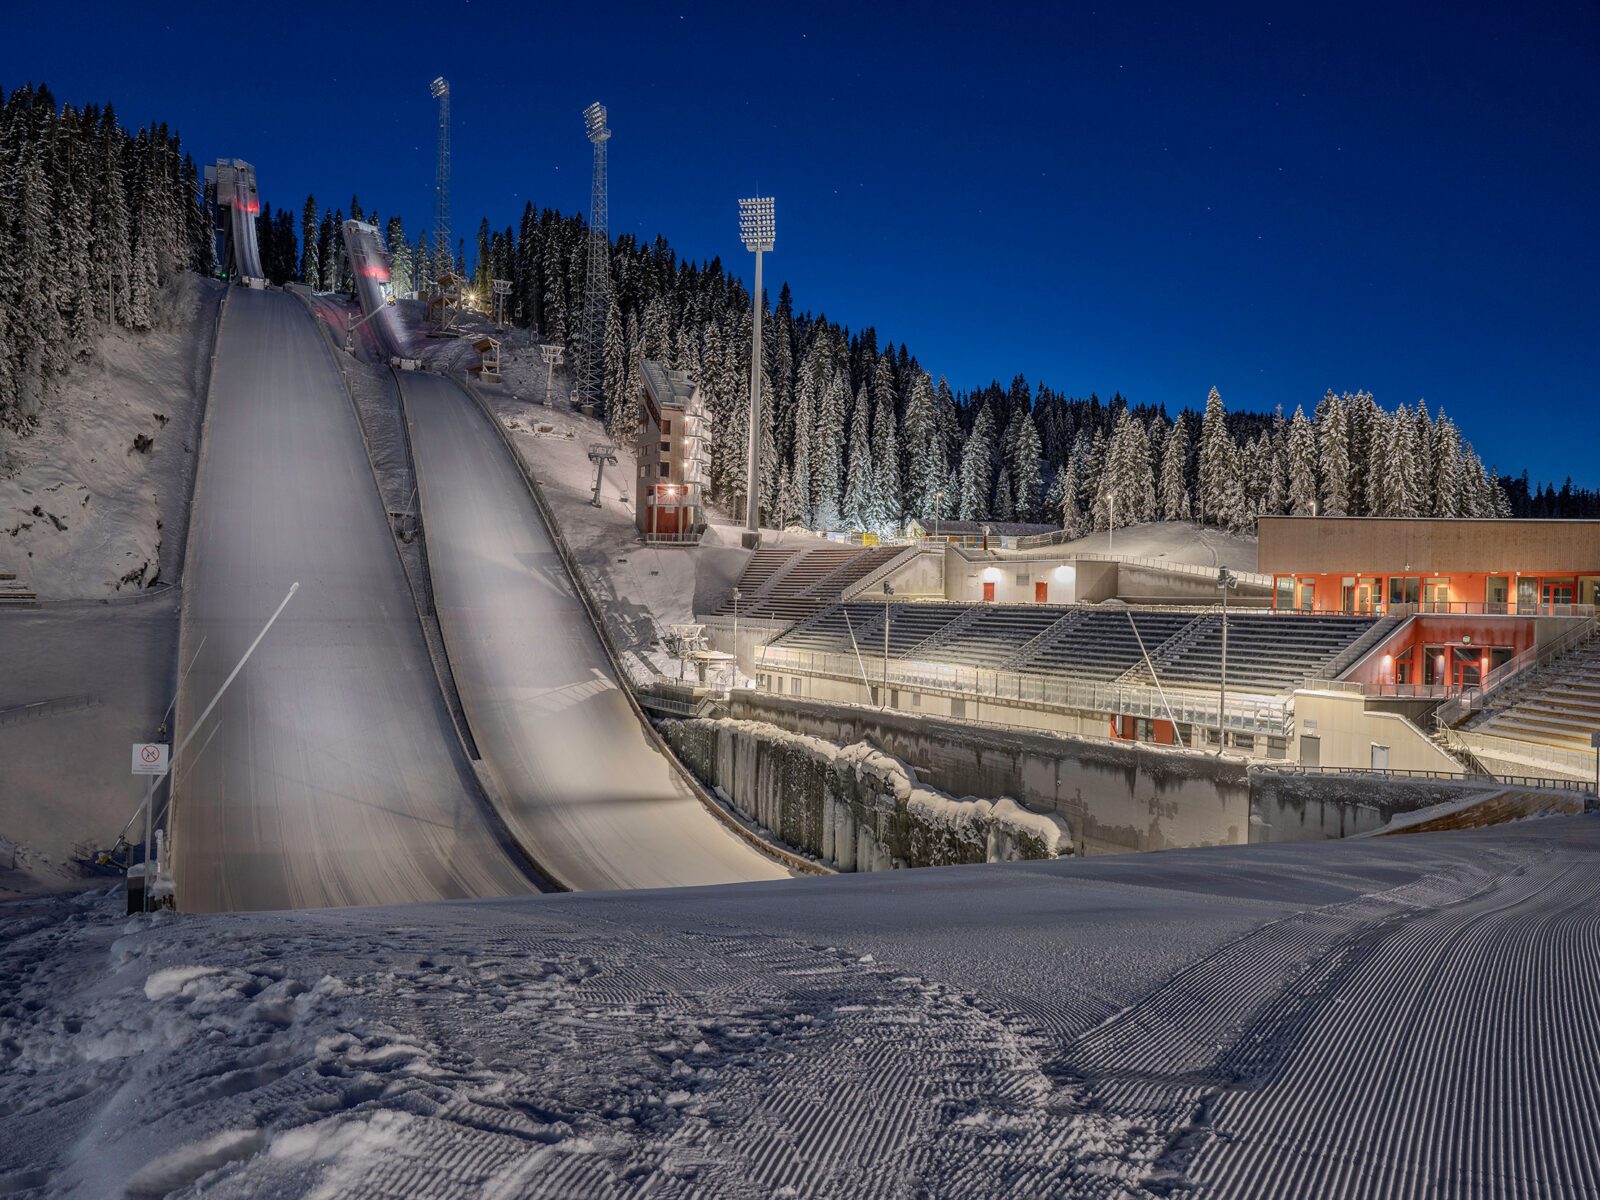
[0, 818, 1600, 1197]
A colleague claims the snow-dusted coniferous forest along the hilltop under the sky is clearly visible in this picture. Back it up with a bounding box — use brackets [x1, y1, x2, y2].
[0, 86, 1600, 533]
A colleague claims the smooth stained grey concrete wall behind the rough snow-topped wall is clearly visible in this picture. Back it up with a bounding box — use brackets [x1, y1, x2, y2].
[730, 691, 1250, 854]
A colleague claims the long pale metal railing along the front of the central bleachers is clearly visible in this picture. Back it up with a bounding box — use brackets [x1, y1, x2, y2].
[763, 646, 1293, 738]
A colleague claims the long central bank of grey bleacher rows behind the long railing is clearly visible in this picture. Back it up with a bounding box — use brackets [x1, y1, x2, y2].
[758, 600, 1376, 694]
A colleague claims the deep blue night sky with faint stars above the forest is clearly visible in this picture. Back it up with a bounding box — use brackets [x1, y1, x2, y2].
[0, 0, 1600, 485]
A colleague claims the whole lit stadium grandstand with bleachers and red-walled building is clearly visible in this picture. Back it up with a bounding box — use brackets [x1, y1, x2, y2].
[702, 518, 1600, 779]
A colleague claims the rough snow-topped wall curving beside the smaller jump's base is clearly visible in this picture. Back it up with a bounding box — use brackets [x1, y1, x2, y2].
[662, 718, 1072, 870]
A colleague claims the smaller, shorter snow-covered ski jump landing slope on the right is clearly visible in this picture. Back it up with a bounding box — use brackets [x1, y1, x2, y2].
[400, 373, 789, 891]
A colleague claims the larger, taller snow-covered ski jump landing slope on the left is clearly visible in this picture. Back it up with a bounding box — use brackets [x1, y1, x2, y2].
[173, 290, 534, 912]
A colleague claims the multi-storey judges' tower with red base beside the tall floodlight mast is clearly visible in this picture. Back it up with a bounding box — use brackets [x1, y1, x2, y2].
[634, 360, 710, 541]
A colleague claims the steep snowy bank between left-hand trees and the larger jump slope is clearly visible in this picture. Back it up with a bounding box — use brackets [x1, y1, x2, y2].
[0, 275, 224, 601]
